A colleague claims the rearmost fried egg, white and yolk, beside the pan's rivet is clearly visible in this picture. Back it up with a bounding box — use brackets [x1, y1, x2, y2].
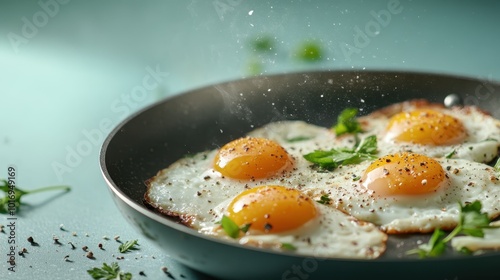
[358, 100, 500, 163]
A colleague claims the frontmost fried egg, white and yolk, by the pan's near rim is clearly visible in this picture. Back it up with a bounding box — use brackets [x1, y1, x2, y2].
[201, 186, 387, 259]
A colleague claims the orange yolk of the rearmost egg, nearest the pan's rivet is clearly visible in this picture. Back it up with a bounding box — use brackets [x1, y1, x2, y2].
[386, 109, 466, 146]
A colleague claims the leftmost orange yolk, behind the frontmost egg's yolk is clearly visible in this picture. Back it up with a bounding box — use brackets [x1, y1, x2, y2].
[214, 137, 291, 179]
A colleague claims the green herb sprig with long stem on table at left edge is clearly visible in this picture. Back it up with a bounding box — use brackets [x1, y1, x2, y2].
[0, 180, 71, 215]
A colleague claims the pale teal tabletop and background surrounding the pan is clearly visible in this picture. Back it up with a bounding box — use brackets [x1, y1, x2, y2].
[0, 0, 500, 279]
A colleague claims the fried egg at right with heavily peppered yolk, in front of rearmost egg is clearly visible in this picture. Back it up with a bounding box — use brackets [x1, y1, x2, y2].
[308, 152, 500, 234]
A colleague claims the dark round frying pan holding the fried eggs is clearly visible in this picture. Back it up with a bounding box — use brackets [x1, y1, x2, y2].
[100, 71, 500, 279]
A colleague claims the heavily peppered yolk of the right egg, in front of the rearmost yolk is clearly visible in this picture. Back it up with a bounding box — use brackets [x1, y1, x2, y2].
[361, 153, 446, 196]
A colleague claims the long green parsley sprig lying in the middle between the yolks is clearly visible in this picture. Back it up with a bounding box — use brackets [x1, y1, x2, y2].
[304, 135, 377, 170]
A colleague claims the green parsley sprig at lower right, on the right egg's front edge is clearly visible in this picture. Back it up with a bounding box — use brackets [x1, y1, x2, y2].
[406, 200, 500, 258]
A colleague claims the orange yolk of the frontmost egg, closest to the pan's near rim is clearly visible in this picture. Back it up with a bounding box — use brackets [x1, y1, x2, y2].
[227, 186, 317, 233]
